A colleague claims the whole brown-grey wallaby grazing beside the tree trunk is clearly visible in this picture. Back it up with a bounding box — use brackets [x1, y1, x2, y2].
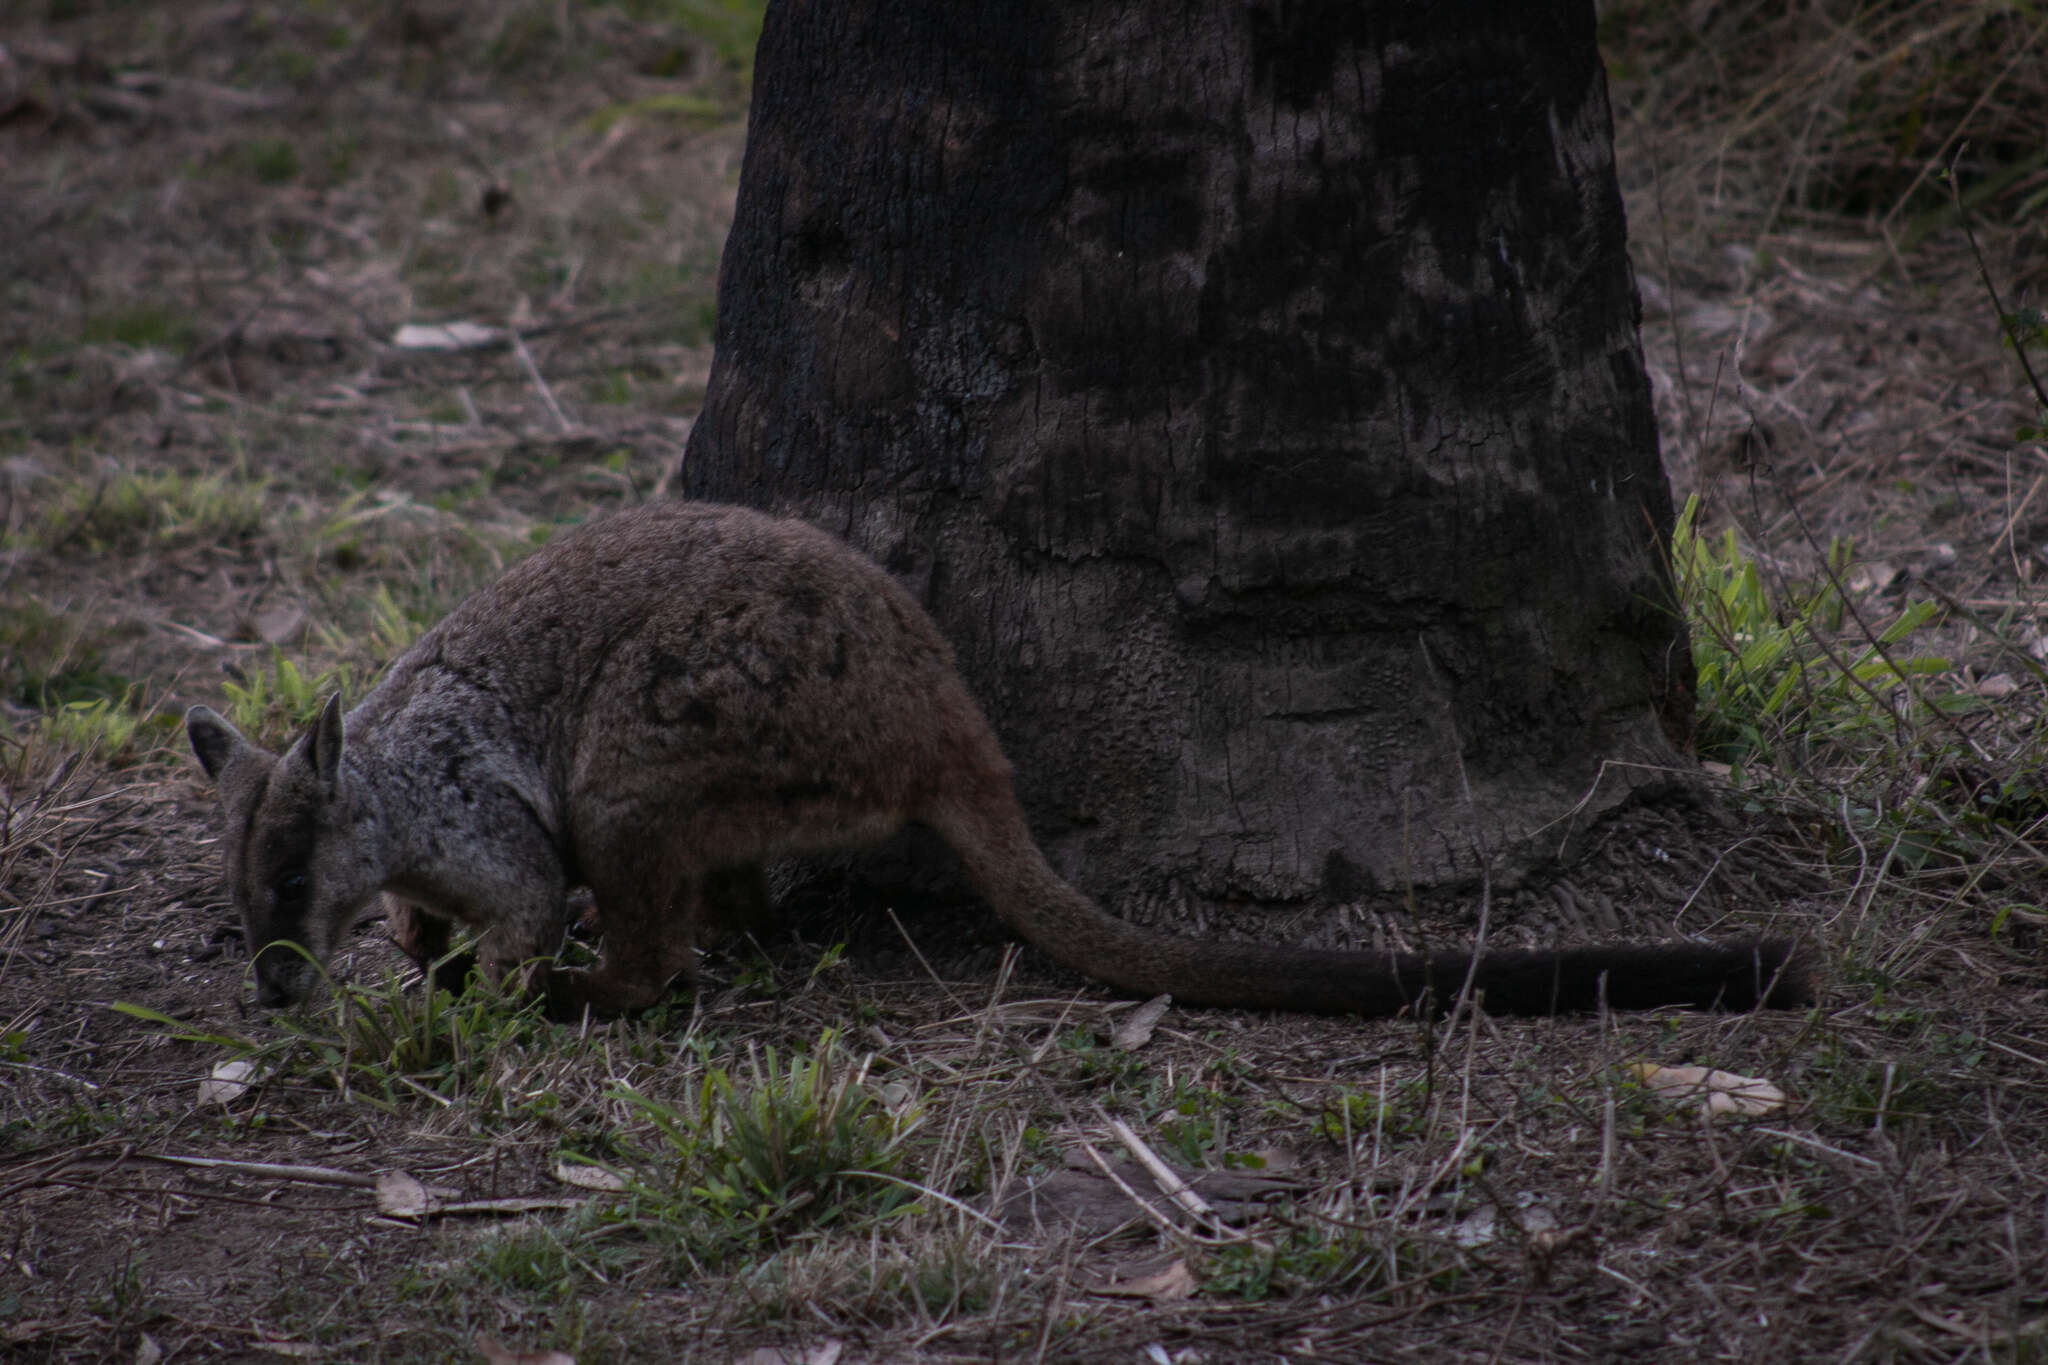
[184, 501, 1812, 1017]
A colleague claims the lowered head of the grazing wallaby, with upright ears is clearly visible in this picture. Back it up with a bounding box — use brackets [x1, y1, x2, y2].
[184, 696, 383, 1005]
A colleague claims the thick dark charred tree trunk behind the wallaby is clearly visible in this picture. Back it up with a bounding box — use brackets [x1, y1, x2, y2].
[680, 0, 1692, 921]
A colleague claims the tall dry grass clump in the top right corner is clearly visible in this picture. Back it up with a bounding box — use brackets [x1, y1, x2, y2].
[1602, 0, 2048, 250]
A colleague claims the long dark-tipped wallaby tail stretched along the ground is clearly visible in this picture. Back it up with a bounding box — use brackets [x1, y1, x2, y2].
[926, 784, 1815, 1017]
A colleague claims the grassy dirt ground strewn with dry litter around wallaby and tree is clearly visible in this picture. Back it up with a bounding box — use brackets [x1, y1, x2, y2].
[0, 0, 2048, 1365]
